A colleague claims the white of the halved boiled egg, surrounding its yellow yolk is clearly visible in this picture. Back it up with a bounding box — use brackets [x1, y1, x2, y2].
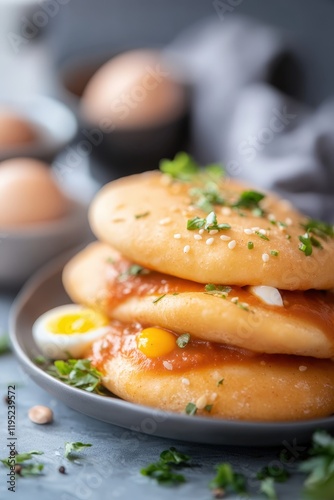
[32, 304, 109, 359]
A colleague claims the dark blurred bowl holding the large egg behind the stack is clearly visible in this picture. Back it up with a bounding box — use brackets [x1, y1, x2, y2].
[58, 47, 190, 182]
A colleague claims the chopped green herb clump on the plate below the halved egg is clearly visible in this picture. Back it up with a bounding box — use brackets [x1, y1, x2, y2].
[45, 359, 106, 395]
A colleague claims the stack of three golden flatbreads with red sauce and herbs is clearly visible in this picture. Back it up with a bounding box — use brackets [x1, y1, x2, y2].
[63, 158, 334, 421]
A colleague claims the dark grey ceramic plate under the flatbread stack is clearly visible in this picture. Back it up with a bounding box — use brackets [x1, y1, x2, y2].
[10, 251, 334, 446]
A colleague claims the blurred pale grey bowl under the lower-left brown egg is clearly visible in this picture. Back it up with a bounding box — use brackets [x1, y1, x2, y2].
[0, 201, 92, 287]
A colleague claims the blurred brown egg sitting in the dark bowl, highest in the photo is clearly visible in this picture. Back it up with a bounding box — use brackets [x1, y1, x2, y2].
[82, 50, 186, 131]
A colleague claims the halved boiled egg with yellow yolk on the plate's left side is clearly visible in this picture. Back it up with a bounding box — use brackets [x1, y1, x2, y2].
[32, 304, 109, 359]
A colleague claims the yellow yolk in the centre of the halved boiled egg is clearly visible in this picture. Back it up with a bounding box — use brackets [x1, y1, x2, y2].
[47, 309, 109, 335]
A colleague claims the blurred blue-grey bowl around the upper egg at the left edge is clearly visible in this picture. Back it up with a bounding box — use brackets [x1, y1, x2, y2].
[0, 95, 78, 163]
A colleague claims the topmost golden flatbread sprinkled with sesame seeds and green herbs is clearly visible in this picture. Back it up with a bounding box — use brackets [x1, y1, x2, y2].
[90, 166, 334, 290]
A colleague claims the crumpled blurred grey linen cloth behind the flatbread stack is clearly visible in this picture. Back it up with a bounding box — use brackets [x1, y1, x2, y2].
[166, 15, 334, 222]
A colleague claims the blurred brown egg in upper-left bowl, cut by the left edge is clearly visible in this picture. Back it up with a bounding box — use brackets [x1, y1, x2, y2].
[0, 108, 38, 149]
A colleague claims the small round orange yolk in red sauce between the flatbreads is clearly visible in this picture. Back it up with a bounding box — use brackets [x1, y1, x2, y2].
[137, 327, 176, 358]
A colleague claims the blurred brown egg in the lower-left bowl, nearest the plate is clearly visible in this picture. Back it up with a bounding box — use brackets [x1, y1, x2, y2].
[0, 158, 69, 229]
